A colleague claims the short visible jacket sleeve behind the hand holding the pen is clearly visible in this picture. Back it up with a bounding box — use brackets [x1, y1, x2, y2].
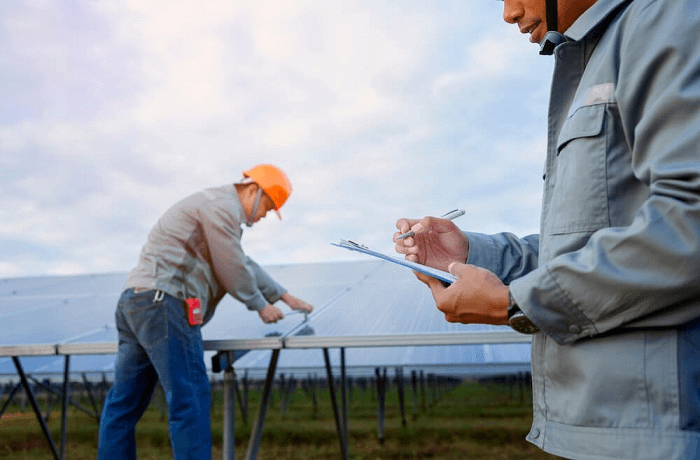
[464, 232, 539, 284]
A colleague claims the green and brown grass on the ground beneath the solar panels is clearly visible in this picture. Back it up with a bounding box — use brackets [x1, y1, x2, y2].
[0, 382, 558, 460]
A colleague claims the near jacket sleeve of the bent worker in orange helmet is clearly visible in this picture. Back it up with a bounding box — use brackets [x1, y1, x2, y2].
[200, 206, 268, 311]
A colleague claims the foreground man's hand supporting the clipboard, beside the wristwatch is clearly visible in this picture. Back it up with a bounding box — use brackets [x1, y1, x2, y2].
[416, 263, 509, 324]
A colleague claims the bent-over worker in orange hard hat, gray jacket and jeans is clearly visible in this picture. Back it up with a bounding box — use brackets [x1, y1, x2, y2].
[98, 164, 313, 460]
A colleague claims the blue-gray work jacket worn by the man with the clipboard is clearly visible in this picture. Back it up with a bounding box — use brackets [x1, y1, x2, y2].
[467, 0, 700, 460]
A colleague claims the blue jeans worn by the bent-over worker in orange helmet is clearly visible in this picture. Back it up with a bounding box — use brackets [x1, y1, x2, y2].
[97, 289, 211, 460]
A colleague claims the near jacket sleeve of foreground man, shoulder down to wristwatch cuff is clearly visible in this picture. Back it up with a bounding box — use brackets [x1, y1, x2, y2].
[511, 1, 700, 344]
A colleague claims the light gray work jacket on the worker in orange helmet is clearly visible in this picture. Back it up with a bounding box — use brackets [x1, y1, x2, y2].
[126, 184, 286, 323]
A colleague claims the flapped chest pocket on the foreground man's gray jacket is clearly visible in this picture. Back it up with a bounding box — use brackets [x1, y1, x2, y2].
[545, 104, 609, 235]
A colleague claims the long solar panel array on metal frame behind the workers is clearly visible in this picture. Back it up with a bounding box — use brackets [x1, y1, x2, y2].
[0, 260, 530, 376]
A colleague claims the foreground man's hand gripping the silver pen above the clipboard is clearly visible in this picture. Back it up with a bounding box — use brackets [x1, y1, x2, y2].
[394, 217, 469, 271]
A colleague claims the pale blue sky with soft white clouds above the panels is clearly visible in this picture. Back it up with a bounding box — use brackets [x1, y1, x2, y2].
[0, 0, 553, 278]
